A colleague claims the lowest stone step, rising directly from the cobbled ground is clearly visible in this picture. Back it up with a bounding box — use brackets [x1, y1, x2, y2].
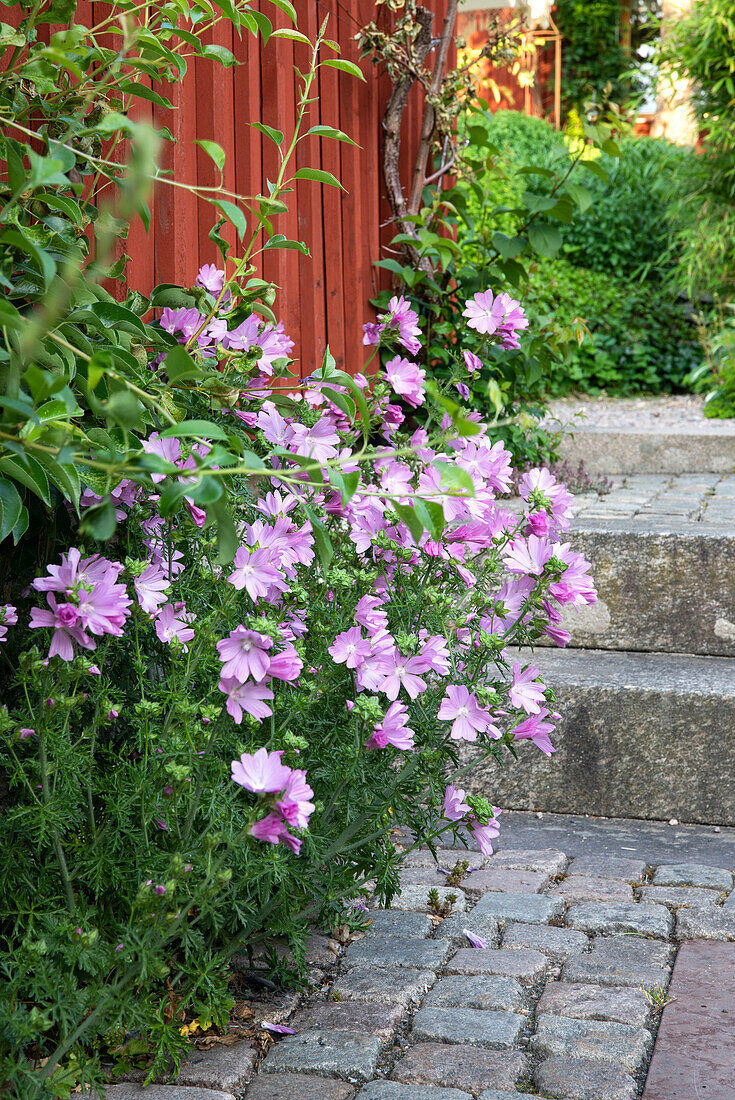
[463, 649, 735, 825]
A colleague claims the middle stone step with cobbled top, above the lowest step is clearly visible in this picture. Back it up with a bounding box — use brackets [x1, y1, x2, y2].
[543, 474, 735, 657]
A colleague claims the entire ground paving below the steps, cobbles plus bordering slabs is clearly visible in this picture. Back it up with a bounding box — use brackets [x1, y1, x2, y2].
[99, 814, 735, 1100]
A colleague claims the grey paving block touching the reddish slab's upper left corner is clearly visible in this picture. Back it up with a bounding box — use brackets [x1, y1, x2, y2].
[561, 936, 670, 990]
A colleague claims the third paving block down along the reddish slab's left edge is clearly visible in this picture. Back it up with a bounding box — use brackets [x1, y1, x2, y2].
[530, 1015, 652, 1074]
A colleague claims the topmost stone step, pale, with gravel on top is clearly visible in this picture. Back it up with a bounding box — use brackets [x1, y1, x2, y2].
[546, 397, 735, 474]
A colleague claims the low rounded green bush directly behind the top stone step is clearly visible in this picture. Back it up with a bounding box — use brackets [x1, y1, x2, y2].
[527, 260, 703, 394]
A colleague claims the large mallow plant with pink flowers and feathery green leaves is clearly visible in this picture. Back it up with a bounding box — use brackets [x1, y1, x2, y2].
[0, 264, 595, 1097]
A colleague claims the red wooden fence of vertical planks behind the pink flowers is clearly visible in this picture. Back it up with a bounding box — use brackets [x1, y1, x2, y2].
[124, 0, 447, 374]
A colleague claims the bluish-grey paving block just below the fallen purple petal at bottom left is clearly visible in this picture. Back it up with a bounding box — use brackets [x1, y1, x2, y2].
[261, 1031, 381, 1081]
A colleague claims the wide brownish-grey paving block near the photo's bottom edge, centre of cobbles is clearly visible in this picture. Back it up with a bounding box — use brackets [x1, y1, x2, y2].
[391, 1043, 528, 1092]
